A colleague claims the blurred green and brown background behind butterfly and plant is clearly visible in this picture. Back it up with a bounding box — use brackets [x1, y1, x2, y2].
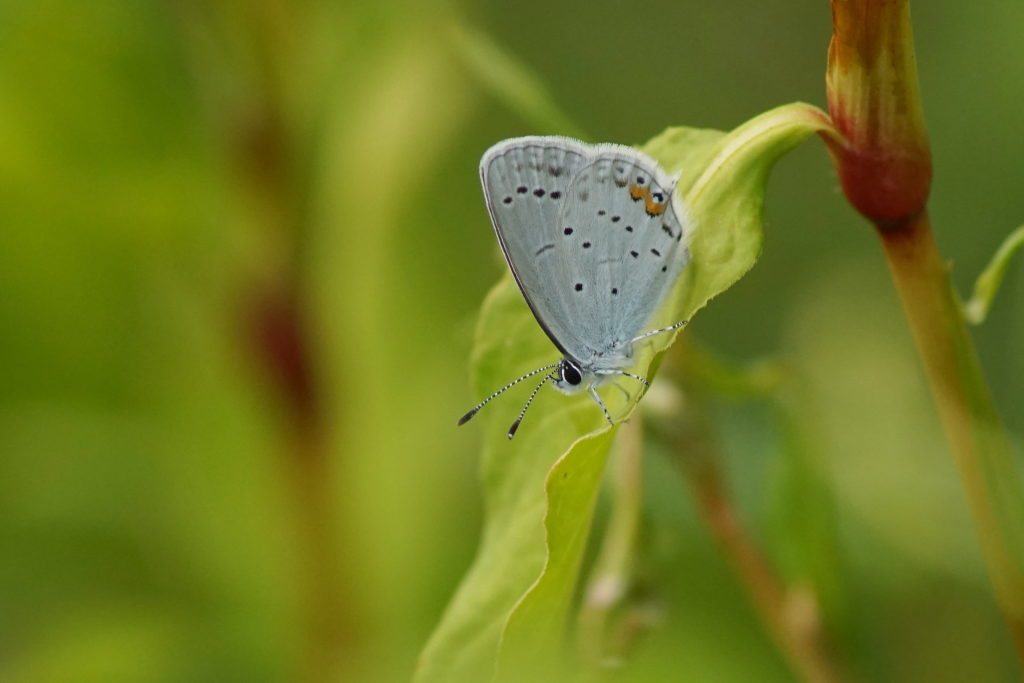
[0, 0, 1024, 682]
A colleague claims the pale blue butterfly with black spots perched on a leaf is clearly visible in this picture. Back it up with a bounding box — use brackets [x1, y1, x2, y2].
[459, 136, 693, 438]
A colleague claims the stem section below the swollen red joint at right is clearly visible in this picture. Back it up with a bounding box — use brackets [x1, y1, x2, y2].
[879, 212, 1024, 665]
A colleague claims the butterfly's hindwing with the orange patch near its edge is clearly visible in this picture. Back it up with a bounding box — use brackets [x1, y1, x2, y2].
[559, 144, 690, 369]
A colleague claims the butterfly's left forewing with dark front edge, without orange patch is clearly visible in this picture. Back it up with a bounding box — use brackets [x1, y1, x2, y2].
[480, 137, 594, 357]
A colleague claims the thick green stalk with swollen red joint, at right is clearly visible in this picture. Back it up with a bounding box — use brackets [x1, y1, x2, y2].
[825, 0, 1024, 665]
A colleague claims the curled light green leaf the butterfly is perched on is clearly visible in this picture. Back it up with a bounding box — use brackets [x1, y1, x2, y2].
[417, 103, 830, 683]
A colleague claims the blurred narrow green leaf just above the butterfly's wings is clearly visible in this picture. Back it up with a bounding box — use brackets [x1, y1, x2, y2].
[451, 25, 588, 139]
